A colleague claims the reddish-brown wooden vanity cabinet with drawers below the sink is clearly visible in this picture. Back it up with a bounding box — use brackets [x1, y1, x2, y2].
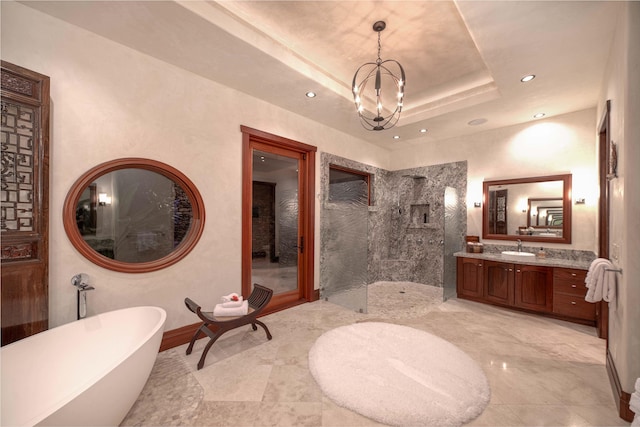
[456, 253, 597, 326]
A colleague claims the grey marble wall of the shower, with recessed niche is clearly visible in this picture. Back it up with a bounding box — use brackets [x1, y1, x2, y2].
[320, 153, 467, 287]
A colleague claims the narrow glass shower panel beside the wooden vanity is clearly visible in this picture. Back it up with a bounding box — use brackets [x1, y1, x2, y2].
[442, 187, 463, 301]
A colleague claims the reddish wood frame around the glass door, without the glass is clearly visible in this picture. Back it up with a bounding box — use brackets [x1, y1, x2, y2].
[240, 126, 317, 313]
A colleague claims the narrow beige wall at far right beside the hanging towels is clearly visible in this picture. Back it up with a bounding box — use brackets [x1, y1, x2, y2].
[598, 2, 640, 393]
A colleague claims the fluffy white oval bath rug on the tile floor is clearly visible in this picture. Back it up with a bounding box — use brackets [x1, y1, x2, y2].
[309, 322, 491, 426]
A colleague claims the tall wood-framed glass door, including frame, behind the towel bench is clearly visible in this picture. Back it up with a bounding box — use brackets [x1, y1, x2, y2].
[241, 126, 316, 312]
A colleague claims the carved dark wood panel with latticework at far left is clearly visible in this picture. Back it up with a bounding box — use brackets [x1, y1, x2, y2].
[0, 61, 49, 345]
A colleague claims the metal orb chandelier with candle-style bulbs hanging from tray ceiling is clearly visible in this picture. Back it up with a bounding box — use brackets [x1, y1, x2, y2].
[351, 21, 406, 130]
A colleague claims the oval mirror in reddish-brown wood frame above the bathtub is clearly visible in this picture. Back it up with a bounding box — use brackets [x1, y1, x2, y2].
[63, 158, 204, 273]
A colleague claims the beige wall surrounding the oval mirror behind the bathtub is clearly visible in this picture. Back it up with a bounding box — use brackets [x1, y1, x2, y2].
[1, 1, 388, 329]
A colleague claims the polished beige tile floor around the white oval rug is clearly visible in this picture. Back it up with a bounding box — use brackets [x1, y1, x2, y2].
[122, 283, 629, 426]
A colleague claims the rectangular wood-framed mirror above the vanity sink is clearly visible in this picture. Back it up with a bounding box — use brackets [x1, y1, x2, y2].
[482, 174, 571, 243]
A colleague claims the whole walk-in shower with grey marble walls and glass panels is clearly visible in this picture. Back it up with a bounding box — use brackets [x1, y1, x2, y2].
[320, 153, 467, 312]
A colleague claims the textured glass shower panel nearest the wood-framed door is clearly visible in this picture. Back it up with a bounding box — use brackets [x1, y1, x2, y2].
[320, 170, 369, 313]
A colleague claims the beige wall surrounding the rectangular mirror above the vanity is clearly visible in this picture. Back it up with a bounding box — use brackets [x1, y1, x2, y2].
[392, 109, 598, 252]
